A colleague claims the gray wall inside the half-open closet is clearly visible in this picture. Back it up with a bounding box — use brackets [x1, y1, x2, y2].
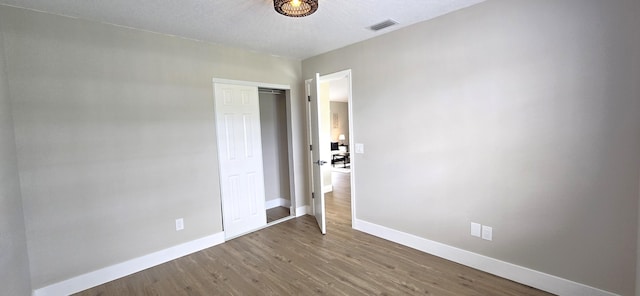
[260, 93, 291, 204]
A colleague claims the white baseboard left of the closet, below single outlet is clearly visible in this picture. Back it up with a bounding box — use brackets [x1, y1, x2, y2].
[32, 232, 225, 296]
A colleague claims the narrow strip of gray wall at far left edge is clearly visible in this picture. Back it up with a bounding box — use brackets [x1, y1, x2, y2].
[0, 19, 31, 295]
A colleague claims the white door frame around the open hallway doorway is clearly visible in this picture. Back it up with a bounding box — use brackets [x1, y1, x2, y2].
[308, 69, 357, 228]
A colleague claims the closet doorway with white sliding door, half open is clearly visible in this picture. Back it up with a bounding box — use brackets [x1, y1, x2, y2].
[213, 79, 295, 240]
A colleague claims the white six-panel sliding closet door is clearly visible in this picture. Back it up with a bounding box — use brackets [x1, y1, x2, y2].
[214, 83, 267, 238]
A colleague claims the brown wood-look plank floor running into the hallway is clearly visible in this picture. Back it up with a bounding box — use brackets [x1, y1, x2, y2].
[77, 173, 551, 296]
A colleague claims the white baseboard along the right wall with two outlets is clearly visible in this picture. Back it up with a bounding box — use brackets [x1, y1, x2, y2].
[353, 219, 618, 296]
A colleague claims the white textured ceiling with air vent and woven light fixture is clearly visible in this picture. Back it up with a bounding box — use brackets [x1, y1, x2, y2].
[0, 0, 484, 59]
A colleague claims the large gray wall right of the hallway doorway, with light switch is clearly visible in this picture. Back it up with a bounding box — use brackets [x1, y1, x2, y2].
[302, 0, 640, 295]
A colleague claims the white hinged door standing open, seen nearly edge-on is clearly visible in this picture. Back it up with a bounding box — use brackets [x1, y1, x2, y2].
[306, 73, 327, 234]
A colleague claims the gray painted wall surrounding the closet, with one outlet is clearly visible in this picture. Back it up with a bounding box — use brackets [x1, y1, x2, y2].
[0, 6, 307, 289]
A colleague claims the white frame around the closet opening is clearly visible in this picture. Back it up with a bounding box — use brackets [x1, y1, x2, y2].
[211, 77, 297, 236]
